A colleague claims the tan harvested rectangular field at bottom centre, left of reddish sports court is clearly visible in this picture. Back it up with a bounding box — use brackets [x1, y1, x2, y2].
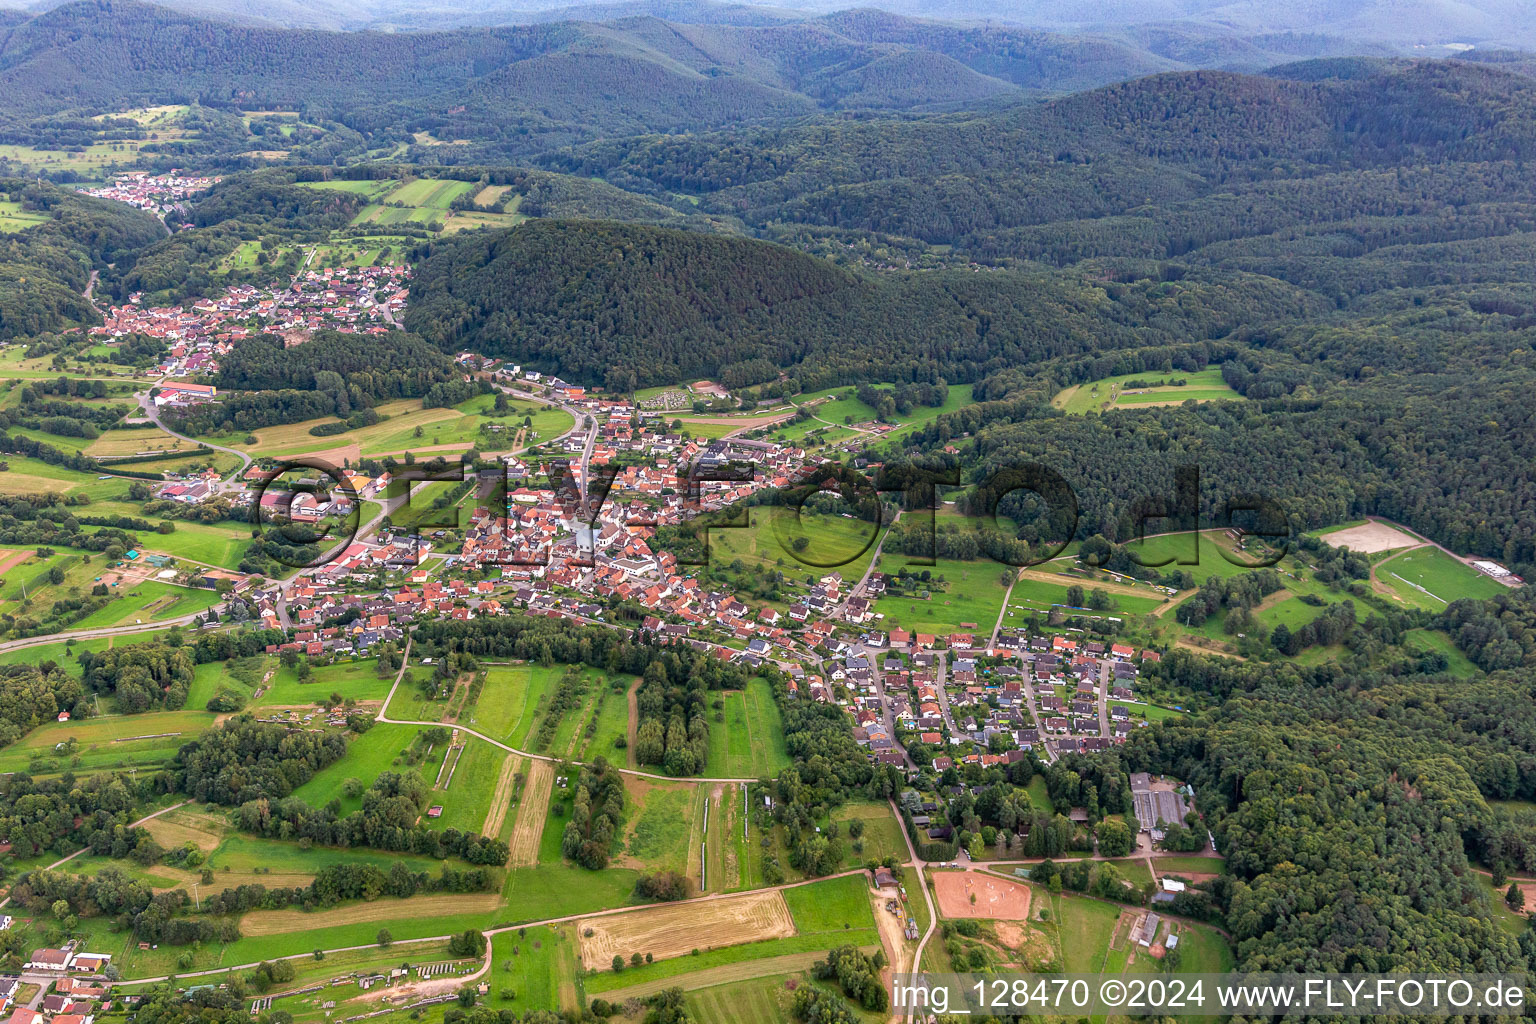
[579, 890, 794, 970]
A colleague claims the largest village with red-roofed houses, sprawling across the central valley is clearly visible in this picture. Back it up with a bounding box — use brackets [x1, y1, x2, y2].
[195, 368, 1177, 792]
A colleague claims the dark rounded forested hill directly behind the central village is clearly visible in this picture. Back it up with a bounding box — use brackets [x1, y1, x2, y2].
[406, 221, 1326, 388]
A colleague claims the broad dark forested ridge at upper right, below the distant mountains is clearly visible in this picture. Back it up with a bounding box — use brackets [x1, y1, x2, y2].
[545, 61, 1536, 254]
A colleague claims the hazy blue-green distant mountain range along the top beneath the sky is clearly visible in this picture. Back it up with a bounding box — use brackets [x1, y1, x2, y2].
[0, 0, 1431, 130]
